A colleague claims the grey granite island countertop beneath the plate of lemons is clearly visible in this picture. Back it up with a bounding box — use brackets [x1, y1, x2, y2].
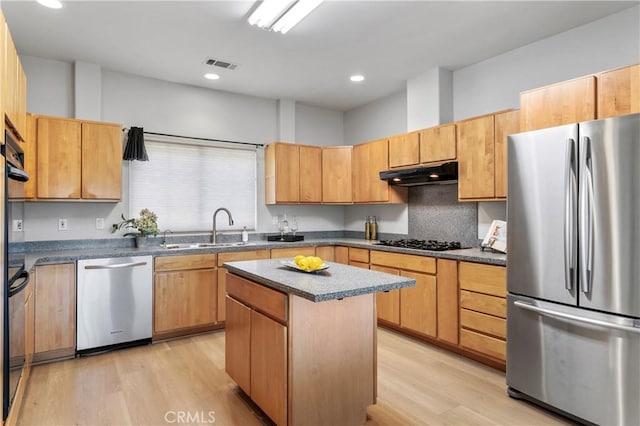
[224, 259, 416, 302]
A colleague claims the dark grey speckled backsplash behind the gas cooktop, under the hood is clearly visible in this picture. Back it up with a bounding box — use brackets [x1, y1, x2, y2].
[409, 184, 478, 247]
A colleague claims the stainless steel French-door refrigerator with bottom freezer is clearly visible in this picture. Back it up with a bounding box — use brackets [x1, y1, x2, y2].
[507, 114, 640, 425]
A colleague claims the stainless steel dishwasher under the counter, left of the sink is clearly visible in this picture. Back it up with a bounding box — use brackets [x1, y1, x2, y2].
[76, 256, 153, 354]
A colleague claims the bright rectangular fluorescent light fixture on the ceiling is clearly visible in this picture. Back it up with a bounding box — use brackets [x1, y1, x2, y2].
[248, 0, 323, 34]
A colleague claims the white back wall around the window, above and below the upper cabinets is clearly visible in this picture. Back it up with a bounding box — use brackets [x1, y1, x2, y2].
[23, 57, 344, 241]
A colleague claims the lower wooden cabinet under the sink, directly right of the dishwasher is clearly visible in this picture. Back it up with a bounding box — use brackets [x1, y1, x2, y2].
[153, 254, 218, 340]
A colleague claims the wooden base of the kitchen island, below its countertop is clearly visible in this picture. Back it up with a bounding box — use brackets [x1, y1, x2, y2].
[225, 274, 377, 425]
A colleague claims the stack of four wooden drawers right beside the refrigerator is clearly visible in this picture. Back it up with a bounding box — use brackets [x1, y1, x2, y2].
[458, 262, 507, 362]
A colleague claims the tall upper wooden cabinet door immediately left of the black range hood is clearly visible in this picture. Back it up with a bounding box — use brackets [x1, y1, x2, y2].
[353, 139, 389, 203]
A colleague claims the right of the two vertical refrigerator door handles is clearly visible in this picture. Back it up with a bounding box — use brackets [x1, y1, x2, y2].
[580, 136, 594, 293]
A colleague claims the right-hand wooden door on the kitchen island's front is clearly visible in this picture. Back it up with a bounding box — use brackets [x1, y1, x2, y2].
[251, 310, 287, 425]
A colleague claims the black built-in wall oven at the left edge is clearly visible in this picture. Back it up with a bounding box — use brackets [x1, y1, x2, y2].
[2, 130, 29, 419]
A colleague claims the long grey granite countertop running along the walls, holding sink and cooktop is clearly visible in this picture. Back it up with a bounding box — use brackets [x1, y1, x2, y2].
[17, 238, 507, 269]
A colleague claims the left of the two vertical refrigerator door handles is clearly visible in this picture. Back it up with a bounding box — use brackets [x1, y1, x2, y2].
[564, 138, 578, 290]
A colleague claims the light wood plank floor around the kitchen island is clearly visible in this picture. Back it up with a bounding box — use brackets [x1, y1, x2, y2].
[18, 329, 570, 426]
